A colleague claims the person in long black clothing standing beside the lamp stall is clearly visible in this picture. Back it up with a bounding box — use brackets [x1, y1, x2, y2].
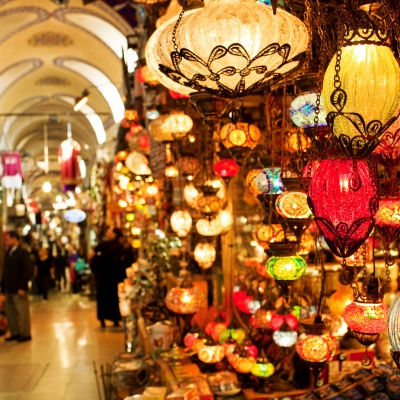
[90, 228, 126, 328]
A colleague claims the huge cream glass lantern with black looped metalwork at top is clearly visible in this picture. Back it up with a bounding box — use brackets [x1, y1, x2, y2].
[146, 0, 309, 98]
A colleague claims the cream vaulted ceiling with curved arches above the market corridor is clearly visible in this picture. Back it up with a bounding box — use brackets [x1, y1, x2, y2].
[0, 0, 133, 205]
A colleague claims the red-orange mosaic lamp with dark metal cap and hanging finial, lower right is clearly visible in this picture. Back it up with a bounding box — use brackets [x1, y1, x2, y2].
[343, 277, 389, 366]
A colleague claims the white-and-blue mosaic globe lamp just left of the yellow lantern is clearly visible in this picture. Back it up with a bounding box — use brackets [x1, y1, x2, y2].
[290, 92, 326, 129]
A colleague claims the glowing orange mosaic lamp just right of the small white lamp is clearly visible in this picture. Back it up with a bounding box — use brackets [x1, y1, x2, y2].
[296, 334, 337, 363]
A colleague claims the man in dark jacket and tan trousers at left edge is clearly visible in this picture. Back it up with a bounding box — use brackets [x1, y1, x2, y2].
[1, 231, 33, 342]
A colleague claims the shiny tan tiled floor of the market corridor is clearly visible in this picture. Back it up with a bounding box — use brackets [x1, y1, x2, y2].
[0, 294, 124, 400]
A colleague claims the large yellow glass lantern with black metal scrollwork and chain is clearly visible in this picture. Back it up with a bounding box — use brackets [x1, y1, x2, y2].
[322, 9, 400, 158]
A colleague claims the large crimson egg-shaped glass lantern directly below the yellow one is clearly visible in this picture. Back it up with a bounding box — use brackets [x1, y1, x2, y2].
[309, 159, 378, 258]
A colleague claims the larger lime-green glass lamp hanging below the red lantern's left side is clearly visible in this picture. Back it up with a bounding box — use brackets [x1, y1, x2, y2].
[266, 256, 307, 283]
